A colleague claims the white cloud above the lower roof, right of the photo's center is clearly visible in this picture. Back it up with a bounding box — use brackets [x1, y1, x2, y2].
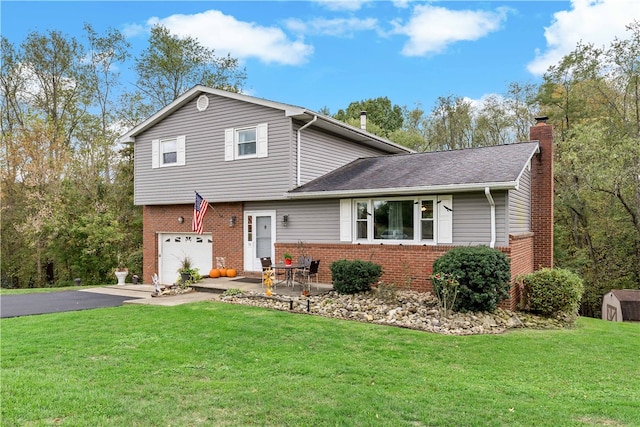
[394, 5, 508, 56]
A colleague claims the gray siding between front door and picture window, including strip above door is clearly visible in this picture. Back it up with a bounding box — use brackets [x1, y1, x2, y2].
[244, 200, 340, 243]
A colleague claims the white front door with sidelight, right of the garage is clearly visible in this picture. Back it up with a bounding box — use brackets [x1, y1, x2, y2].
[244, 211, 276, 271]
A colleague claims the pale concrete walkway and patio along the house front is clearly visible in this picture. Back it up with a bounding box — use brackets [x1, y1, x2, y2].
[81, 277, 333, 306]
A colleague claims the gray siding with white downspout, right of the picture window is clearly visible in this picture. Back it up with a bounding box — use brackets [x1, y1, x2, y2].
[453, 191, 508, 246]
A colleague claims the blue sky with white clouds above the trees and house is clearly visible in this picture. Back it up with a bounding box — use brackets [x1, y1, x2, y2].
[0, 0, 640, 113]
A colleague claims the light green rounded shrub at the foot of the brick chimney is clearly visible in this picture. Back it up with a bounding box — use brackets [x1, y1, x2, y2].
[517, 268, 584, 316]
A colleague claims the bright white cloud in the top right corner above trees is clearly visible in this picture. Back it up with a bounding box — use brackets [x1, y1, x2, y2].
[527, 0, 640, 75]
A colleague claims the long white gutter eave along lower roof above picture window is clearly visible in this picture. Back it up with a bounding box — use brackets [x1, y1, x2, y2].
[285, 181, 518, 199]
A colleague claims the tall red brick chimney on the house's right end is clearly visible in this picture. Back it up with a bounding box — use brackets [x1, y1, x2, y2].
[529, 117, 554, 270]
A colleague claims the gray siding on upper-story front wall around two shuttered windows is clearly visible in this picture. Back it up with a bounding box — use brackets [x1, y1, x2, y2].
[135, 95, 295, 205]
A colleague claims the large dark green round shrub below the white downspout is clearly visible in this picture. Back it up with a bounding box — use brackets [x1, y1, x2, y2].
[433, 246, 511, 311]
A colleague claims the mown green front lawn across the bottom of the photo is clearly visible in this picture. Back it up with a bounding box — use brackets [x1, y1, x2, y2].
[0, 302, 640, 427]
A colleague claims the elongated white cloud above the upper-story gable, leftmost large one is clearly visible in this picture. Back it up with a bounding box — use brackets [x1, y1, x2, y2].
[147, 10, 313, 65]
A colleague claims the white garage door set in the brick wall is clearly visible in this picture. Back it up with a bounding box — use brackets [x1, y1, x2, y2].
[158, 233, 213, 284]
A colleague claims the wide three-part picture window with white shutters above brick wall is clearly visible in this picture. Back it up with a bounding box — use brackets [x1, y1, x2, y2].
[340, 195, 453, 244]
